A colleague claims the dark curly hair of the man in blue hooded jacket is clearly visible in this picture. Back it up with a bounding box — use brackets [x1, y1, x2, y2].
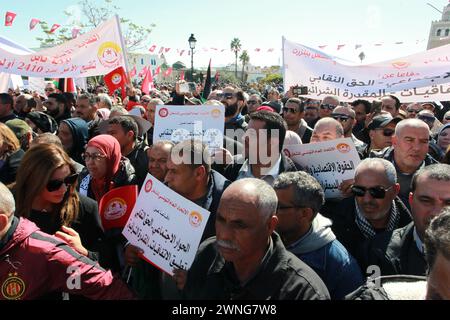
[273, 171, 325, 215]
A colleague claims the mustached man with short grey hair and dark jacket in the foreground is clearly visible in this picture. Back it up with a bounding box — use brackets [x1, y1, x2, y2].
[183, 179, 330, 300]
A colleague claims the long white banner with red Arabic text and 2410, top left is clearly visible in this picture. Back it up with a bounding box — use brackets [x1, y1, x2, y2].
[0, 16, 125, 78]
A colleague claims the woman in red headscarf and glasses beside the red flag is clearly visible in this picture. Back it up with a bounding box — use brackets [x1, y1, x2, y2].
[79, 134, 137, 272]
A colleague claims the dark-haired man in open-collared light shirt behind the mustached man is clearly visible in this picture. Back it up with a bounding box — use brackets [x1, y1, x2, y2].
[224, 111, 298, 185]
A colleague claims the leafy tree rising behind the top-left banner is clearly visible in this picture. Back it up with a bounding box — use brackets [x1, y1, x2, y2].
[36, 0, 155, 52]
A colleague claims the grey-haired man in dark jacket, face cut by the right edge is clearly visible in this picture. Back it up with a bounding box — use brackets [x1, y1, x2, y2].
[368, 164, 450, 276]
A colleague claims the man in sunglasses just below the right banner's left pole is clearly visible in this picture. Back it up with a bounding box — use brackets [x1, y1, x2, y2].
[282, 98, 313, 143]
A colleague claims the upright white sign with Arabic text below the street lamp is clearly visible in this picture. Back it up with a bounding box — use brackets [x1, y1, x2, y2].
[153, 105, 225, 153]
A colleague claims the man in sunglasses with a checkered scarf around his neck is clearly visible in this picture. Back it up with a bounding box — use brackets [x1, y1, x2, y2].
[331, 158, 411, 273]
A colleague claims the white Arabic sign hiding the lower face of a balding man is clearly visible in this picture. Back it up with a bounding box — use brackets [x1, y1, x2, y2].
[283, 138, 360, 199]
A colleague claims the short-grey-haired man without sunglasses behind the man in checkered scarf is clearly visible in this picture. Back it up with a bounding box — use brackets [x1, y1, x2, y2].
[371, 119, 437, 208]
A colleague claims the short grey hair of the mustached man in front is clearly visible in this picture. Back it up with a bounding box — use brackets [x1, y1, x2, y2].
[230, 178, 278, 219]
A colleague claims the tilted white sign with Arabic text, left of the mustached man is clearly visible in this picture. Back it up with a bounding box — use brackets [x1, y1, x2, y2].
[122, 174, 209, 275]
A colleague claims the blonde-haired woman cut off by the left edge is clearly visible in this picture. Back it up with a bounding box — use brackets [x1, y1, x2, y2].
[0, 122, 25, 185]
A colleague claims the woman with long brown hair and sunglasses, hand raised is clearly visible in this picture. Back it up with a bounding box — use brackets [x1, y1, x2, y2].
[13, 144, 103, 260]
